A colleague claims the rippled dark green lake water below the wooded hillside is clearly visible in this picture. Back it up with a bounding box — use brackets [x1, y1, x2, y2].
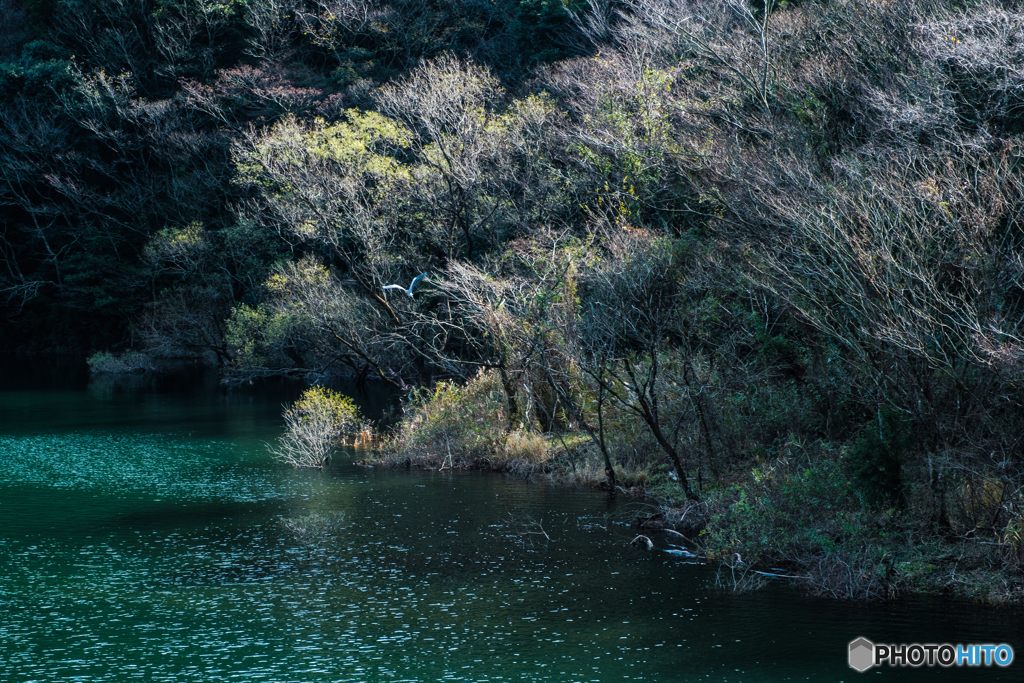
[0, 366, 1024, 683]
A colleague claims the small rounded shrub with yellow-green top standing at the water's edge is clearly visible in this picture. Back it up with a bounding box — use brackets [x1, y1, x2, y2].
[270, 386, 362, 469]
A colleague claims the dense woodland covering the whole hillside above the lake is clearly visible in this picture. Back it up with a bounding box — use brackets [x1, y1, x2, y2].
[0, 0, 1024, 599]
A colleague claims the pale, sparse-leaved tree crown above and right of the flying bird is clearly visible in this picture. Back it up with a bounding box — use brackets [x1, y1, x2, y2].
[376, 54, 558, 260]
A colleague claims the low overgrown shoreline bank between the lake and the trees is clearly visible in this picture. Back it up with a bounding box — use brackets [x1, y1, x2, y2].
[355, 446, 1024, 608]
